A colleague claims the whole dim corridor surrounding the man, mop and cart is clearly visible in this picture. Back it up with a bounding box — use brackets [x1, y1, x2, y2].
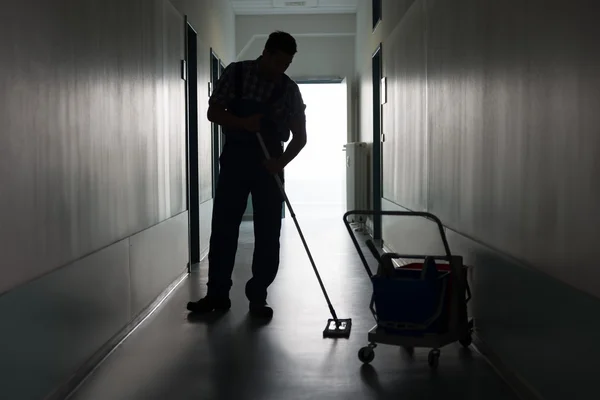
[0, 0, 600, 400]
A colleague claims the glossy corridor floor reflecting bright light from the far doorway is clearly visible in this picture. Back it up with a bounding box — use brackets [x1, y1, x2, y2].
[72, 208, 517, 400]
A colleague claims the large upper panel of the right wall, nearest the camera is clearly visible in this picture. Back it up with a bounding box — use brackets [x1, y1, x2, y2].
[428, 0, 600, 295]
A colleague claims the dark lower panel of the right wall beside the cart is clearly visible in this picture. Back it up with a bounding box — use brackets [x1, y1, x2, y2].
[448, 231, 600, 400]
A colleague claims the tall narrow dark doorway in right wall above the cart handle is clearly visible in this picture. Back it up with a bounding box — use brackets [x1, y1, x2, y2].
[371, 44, 383, 242]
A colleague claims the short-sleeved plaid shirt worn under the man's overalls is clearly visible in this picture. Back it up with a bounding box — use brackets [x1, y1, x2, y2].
[208, 57, 306, 138]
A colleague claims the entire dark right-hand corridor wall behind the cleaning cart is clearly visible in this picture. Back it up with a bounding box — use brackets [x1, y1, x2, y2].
[357, 0, 600, 399]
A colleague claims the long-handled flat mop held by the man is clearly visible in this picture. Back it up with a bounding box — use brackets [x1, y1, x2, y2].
[256, 132, 352, 338]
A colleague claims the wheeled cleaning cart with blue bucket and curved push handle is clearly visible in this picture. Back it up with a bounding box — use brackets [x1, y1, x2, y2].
[344, 211, 473, 368]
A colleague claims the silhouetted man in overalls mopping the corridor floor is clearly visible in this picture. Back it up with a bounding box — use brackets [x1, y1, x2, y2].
[187, 32, 306, 319]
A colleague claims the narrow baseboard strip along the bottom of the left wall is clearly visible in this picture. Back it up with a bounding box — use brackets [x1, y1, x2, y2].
[45, 272, 188, 400]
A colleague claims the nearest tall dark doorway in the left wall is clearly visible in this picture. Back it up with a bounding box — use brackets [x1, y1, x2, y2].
[182, 17, 200, 270]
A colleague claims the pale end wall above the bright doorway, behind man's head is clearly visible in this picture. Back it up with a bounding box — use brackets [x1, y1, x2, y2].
[236, 14, 356, 78]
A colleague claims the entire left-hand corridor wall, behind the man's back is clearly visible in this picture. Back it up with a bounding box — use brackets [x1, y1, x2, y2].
[0, 0, 235, 400]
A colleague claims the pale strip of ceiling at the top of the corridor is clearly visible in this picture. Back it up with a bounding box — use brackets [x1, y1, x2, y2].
[230, 0, 358, 15]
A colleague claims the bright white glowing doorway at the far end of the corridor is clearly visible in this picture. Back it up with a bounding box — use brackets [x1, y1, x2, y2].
[285, 81, 348, 217]
